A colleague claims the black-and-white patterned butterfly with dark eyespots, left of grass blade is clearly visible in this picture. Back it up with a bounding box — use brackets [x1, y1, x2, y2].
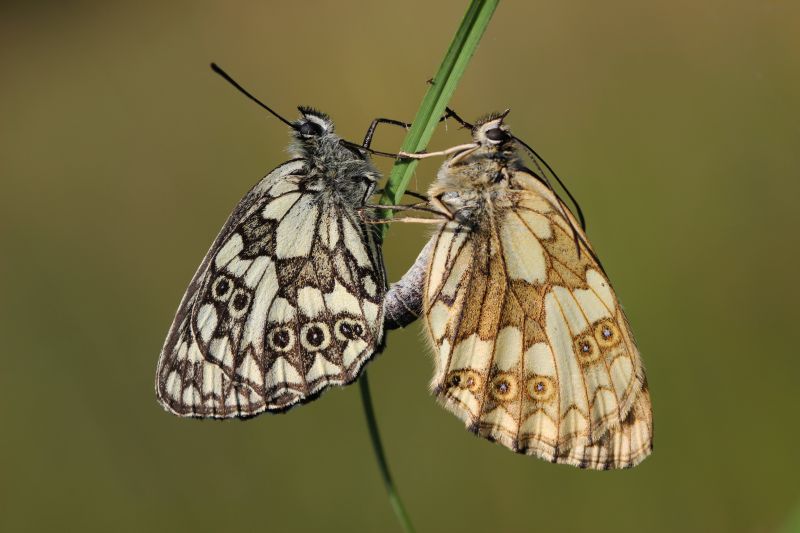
[156, 65, 386, 418]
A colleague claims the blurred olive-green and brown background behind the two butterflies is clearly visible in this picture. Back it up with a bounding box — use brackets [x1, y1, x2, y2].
[0, 0, 800, 532]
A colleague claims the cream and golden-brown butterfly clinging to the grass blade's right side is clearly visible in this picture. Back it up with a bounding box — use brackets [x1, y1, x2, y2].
[384, 112, 653, 469]
